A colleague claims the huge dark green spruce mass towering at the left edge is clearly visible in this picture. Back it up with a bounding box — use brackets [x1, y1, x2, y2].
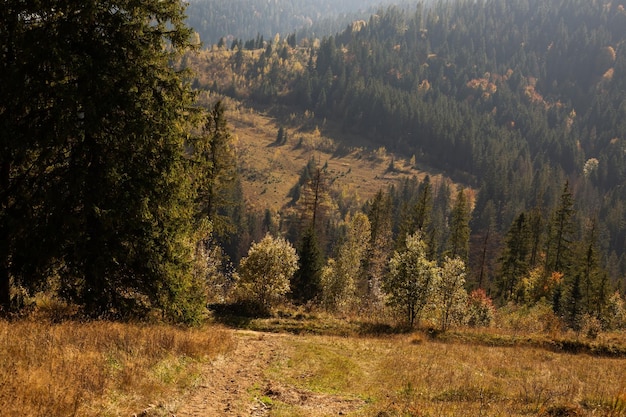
[0, 0, 207, 320]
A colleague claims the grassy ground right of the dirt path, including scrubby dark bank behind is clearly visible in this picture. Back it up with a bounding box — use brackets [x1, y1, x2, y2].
[208, 311, 626, 417]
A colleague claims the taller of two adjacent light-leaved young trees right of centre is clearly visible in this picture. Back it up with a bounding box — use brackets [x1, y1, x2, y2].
[383, 232, 438, 326]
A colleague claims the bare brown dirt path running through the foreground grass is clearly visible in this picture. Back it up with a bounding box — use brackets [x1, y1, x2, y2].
[176, 331, 363, 417]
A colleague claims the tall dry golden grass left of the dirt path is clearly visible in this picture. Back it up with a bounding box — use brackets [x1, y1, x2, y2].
[0, 320, 231, 417]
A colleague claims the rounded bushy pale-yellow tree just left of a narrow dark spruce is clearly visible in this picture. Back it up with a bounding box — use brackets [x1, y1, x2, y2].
[238, 233, 298, 311]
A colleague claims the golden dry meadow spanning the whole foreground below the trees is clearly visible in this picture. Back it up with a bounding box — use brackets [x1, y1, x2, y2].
[0, 312, 626, 417]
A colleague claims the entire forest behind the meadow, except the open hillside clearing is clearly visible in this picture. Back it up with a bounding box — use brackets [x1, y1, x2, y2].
[0, 0, 626, 330]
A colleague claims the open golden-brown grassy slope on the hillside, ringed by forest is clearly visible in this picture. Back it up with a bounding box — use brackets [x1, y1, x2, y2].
[217, 100, 443, 211]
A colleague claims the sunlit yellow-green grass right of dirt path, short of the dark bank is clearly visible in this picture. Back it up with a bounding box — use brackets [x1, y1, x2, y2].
[260, 334, 626, 417]
